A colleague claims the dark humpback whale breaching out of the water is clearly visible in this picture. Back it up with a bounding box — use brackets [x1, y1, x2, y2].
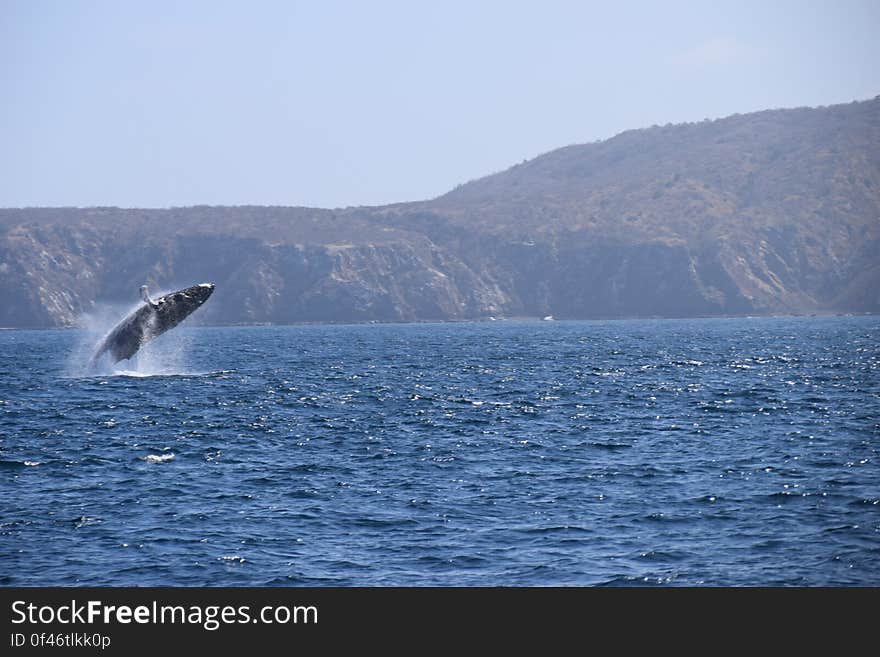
[92, 283, 214, 366]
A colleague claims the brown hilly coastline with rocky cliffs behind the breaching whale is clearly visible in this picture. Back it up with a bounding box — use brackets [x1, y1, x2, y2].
[0, 99, 880, 327]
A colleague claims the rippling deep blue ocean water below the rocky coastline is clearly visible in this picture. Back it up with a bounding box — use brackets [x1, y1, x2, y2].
[0, 317, 880, 586]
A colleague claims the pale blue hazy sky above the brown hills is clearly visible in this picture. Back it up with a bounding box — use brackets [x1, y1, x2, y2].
[0, 0, 880, 207]
